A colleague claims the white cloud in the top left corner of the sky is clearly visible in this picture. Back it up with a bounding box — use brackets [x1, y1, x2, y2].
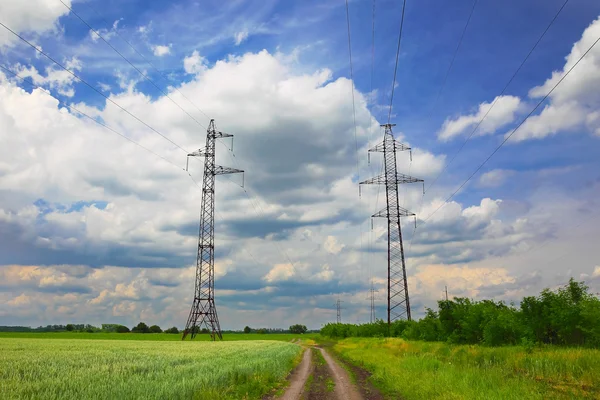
[0, 0, 71, 47]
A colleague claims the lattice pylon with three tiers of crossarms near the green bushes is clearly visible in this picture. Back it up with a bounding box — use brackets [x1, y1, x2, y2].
[360, 124, 425, 326]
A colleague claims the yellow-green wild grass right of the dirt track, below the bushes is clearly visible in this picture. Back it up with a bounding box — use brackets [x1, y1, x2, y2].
[333, 339, 600, 400]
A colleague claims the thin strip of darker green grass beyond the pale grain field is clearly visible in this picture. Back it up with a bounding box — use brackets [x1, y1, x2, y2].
[0, 332, 319, 342]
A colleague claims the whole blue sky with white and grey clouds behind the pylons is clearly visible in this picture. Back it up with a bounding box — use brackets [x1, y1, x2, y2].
[0, 0, 600, 329]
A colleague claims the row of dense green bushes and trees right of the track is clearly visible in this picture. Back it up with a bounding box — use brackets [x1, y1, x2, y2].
[321, 278, 600, 348]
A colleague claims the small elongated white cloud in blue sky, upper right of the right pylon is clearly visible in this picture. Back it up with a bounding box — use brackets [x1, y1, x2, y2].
[437, 96, 521, 141]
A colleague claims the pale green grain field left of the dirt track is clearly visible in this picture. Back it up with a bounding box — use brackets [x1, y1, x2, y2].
[0, 335, 301, 399]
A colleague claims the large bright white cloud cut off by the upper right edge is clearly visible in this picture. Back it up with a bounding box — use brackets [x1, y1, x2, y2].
[507, 17, 600, 141]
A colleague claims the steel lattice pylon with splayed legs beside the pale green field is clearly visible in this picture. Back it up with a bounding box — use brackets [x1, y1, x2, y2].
[182, 119, 244, 340]
